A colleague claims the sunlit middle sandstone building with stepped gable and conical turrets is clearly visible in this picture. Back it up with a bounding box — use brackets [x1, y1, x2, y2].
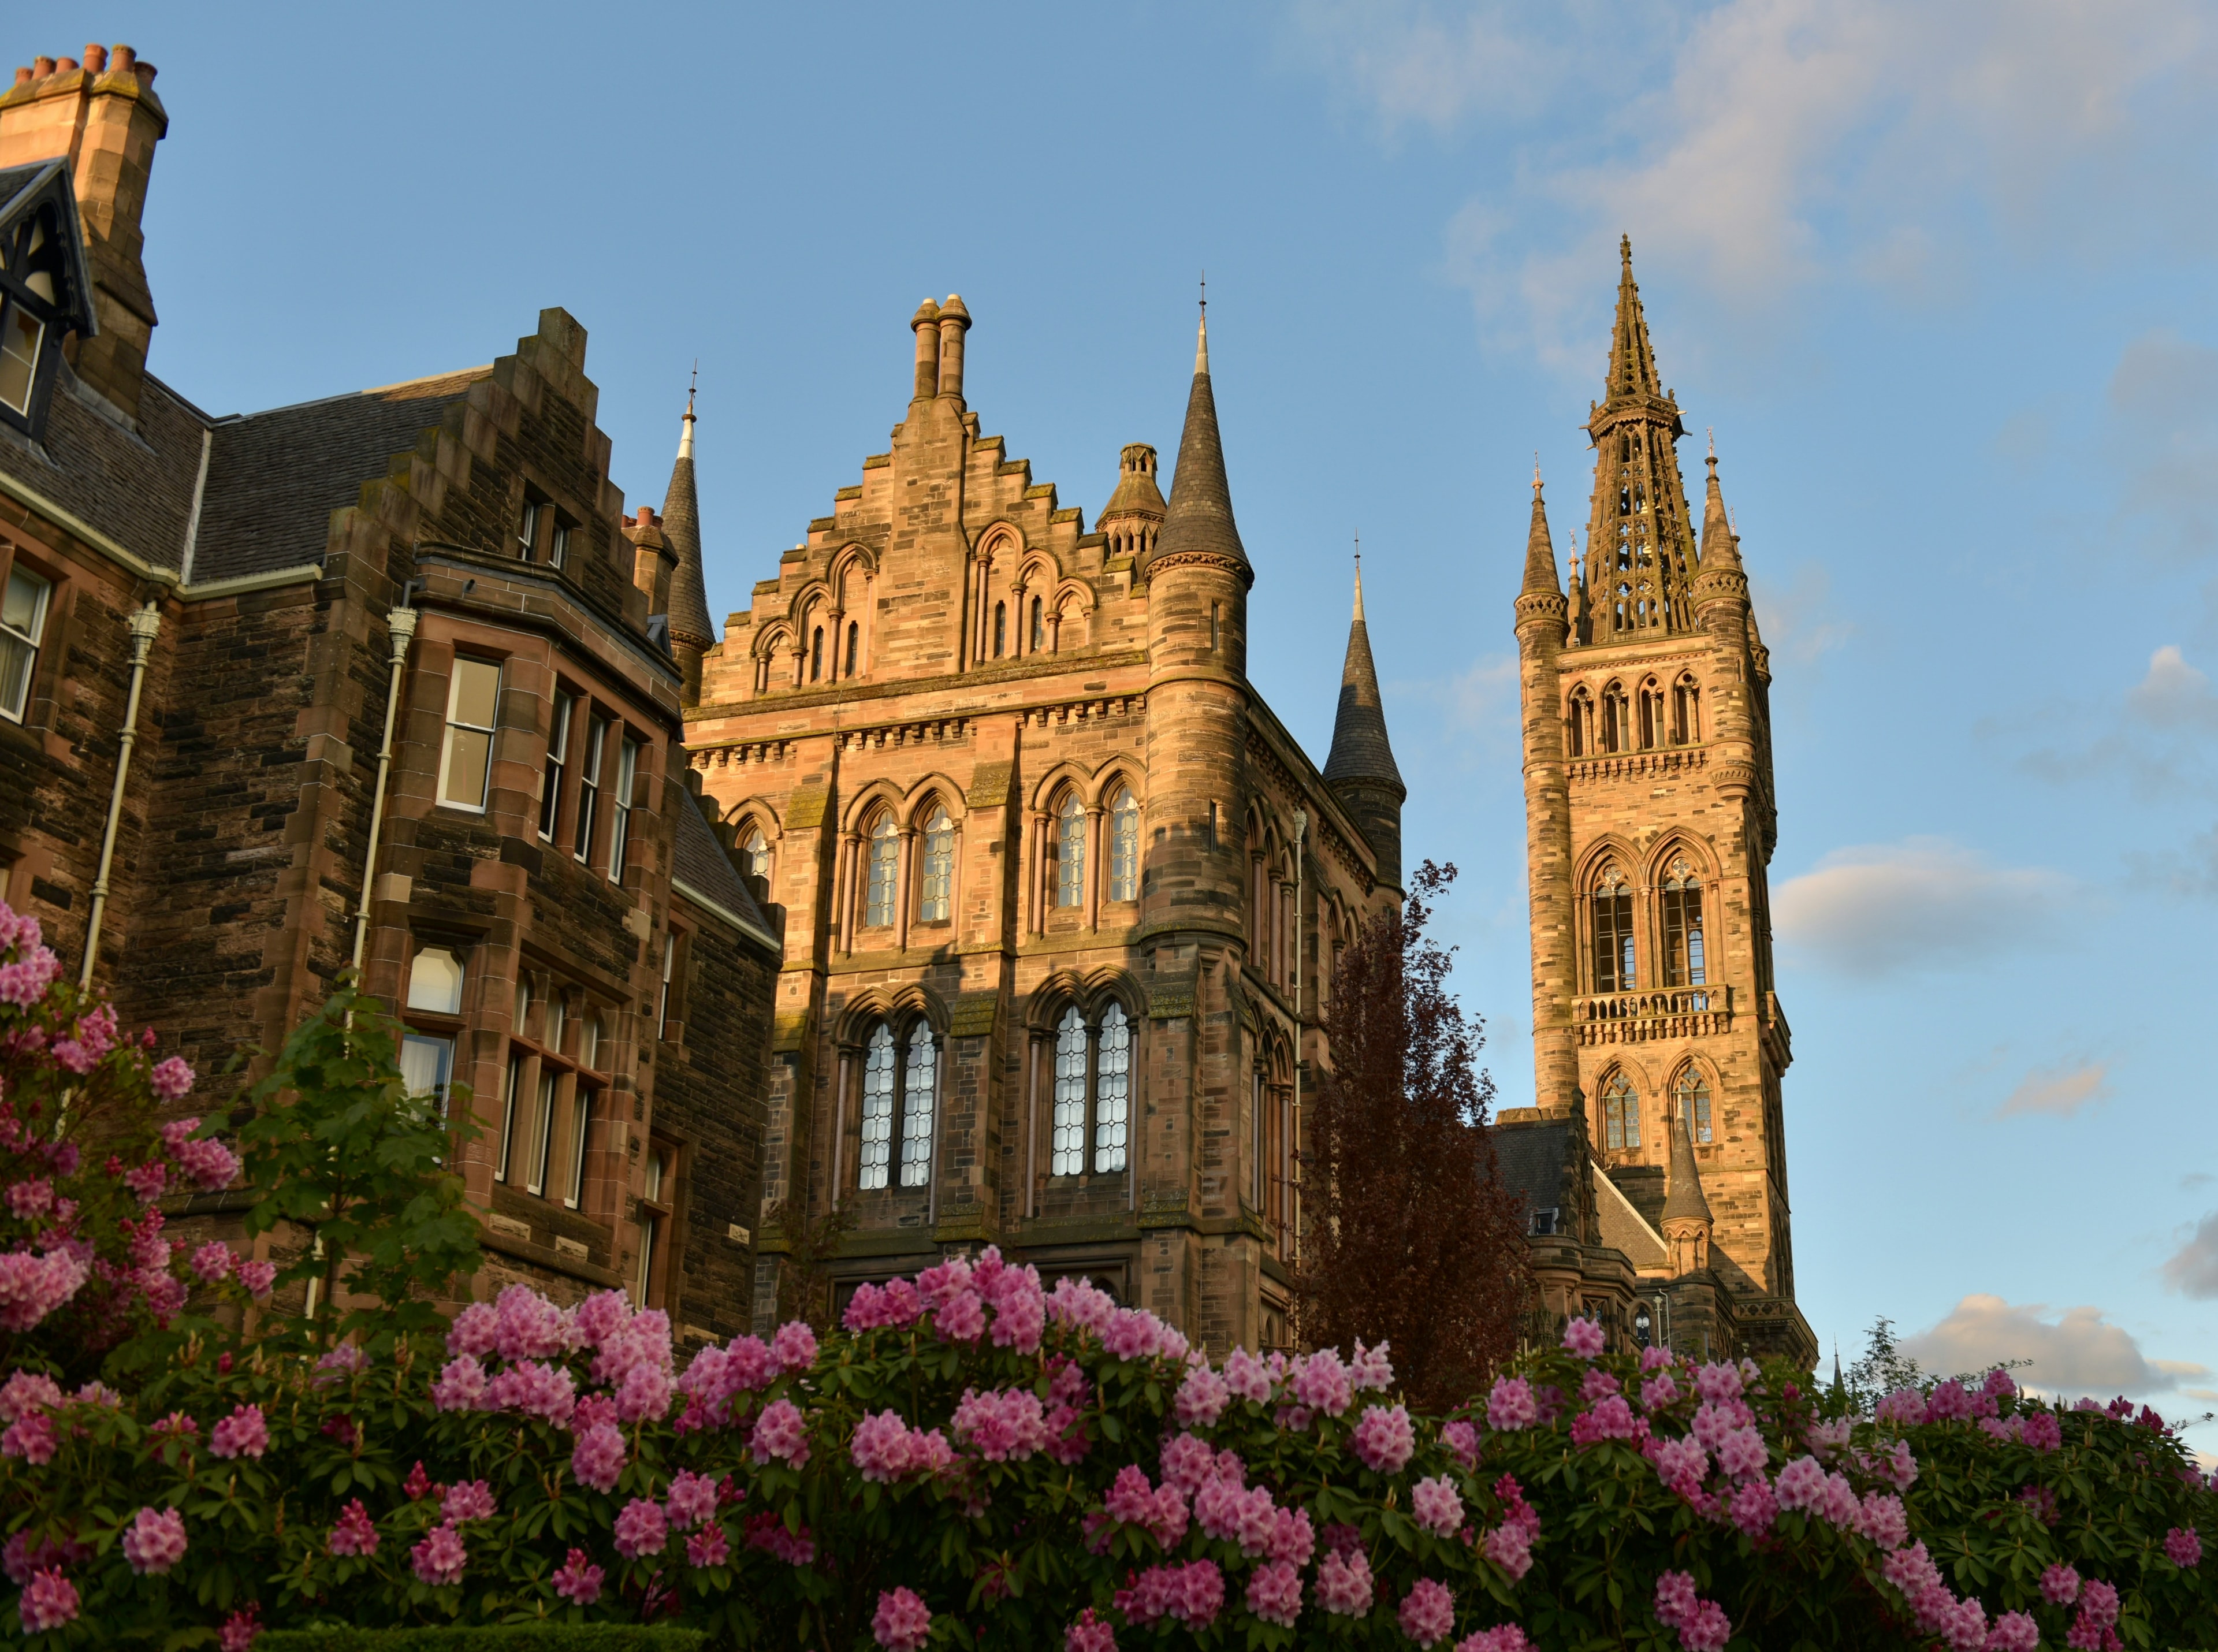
[672, 297, 1404, 1348]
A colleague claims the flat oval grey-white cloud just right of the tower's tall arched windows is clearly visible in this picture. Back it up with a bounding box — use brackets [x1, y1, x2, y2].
[1772, 838, 2072, 978]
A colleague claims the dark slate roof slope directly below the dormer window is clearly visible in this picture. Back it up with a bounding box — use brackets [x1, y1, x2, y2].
[0, 364, 209, 570]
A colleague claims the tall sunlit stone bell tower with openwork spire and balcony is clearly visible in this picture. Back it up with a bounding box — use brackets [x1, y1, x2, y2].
[1515, 244, 1817, 1359]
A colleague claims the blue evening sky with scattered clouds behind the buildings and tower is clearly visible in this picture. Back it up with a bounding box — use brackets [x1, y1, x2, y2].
[47, 0, 2218, 1450]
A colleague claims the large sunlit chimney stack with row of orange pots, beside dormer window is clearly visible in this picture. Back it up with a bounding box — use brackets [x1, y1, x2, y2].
[0, 44, 169, 419]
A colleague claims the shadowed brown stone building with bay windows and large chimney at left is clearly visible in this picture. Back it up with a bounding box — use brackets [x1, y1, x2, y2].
[0, 47, 779, 1335]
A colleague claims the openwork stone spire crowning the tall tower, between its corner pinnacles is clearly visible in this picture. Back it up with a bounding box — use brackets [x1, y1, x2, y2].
[1586, 240, 1695, 643]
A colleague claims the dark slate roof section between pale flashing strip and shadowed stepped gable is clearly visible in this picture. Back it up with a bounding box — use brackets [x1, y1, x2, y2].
[193, 366, 492, 585]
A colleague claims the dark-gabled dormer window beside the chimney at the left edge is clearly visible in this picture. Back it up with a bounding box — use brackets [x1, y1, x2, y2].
[0, 159, 98, 439]
